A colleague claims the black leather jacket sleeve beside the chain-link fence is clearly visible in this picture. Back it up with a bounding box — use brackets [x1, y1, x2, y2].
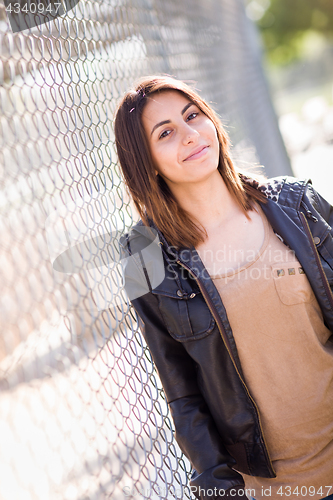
[119, 236, 246, 500]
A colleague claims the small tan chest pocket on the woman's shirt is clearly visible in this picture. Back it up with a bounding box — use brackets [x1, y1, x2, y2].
[272, 261, 315, 306]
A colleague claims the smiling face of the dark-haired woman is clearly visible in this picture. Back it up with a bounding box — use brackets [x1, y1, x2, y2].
[142, 90, 219, 189]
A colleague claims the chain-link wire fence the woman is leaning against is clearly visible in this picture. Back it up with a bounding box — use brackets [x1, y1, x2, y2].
[0, 0, 290, 500]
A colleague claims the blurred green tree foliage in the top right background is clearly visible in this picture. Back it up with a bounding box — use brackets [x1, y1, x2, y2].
[246, 0, 333, 64]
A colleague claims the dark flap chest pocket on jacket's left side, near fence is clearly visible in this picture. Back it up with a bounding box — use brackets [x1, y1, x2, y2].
[152, 290, 215, 342]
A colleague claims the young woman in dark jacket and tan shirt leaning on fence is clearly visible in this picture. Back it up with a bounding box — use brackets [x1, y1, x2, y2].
[115, 77, 333, 500]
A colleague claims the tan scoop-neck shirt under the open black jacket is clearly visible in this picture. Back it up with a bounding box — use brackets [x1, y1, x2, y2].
[212, 207, 333, 500]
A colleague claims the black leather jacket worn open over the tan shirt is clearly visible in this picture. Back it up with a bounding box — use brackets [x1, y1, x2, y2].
[121, 177, 333, 500]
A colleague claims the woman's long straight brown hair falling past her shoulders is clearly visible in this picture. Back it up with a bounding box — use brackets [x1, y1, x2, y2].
[114, 76, 266, 247]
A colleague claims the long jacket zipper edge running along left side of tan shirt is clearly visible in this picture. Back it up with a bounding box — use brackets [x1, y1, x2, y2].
[177, 260, 276, 477]
